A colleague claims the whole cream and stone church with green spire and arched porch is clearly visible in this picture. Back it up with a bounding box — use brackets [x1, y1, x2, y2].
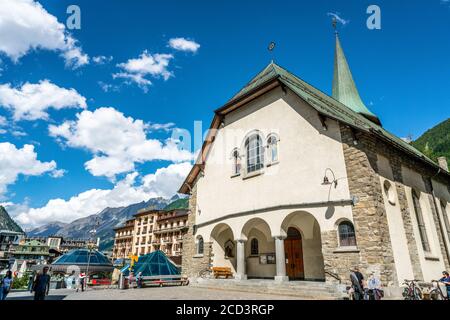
[179, 34, 450, 296]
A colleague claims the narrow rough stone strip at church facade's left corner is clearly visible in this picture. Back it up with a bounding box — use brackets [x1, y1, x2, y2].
[181, 185, 211, 278]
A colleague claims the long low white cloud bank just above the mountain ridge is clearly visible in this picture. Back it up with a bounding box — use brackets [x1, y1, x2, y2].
[7, 163, 191, 227]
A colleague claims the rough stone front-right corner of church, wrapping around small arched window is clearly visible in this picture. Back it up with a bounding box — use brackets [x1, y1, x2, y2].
[322, 125, 397, 285]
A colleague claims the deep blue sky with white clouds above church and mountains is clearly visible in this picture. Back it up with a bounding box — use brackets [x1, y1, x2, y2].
[0, 0, 450, 230]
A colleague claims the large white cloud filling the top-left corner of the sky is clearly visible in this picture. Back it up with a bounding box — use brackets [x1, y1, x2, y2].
[0, 0, 89, 68]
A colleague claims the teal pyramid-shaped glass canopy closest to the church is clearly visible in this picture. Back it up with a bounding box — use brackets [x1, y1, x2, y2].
[121, 250, 180, 277]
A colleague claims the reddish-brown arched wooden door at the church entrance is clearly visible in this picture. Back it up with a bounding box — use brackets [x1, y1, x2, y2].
[284, 227, 305, 280]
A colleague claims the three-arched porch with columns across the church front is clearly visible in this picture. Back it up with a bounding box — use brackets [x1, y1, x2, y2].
[196, 212, 325, 281]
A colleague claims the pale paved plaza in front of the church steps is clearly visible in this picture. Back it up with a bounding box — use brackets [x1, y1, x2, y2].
[7, 286, 296, 300]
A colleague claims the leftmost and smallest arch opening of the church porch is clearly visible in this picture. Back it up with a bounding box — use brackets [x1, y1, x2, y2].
[210, 223, 236, 273]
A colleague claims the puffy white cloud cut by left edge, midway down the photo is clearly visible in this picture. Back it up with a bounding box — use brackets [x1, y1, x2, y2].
[0, 142, 57, 198]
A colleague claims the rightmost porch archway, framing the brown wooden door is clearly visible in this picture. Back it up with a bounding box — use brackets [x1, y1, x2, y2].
[281, 211, 325, 281]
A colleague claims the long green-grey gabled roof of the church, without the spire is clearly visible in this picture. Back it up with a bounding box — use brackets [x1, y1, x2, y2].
[179, 62, 450, 193]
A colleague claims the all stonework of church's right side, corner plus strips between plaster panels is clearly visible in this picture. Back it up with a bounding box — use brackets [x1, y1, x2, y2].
[322, 124, 450, 286]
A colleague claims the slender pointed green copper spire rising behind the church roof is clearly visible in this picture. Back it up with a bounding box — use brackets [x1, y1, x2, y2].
[333, 32, 381, 125]
